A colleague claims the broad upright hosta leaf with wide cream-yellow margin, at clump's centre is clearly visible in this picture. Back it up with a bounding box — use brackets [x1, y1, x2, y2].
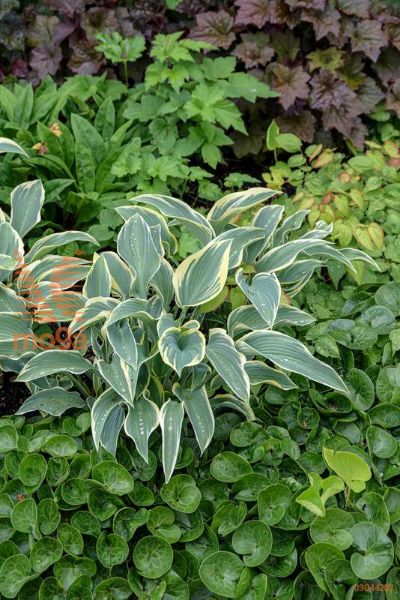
[173, 240, 231, 306]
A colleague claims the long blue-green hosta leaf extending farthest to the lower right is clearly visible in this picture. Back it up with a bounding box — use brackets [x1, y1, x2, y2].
[237, 331, 349, 395]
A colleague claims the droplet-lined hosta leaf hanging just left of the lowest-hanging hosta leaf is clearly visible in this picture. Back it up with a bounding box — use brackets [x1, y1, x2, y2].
[124, 396, 160, 462]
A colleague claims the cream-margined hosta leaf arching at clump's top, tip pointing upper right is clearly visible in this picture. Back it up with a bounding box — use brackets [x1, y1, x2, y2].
[207, 188, 279, 223]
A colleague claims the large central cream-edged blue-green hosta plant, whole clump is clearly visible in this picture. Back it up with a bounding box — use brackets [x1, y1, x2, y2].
[18, 188, 373, 480]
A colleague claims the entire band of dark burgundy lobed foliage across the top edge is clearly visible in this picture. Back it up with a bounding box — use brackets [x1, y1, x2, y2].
[0, 0, 400, 148]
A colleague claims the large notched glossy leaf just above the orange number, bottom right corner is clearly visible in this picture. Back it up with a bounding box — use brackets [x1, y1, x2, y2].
[350, 523, 394, 579]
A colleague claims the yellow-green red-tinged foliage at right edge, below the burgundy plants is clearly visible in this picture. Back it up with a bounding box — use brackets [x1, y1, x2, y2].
[263, 122, 400, 283]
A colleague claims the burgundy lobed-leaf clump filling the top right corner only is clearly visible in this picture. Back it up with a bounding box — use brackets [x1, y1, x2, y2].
[189, 0, 400, 154]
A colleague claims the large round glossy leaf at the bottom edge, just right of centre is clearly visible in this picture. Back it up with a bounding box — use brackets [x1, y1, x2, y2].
[199, 551, 245, 598]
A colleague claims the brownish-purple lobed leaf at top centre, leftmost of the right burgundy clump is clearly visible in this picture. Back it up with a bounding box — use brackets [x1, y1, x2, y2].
[191, 10, 236, 50]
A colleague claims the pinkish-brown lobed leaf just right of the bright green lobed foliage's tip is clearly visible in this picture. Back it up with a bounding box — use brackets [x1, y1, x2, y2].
[267, 63, 310, 110]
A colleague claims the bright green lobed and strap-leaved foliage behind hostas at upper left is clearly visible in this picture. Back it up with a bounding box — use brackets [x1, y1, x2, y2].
[0, 33, 276, 244]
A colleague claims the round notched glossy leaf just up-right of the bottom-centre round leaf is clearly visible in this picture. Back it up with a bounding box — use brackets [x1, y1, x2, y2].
[232, 521, 272, 567]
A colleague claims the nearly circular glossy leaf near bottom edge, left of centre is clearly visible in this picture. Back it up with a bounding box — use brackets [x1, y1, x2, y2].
[132, 536, 173, 579]
